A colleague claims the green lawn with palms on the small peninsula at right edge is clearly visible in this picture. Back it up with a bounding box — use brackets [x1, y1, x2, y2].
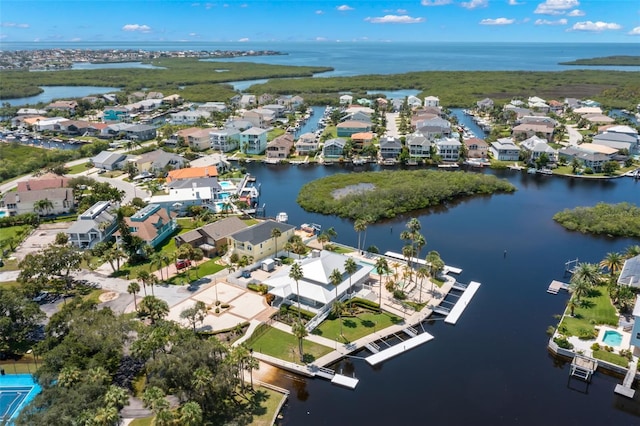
[559, 285, 618, 336]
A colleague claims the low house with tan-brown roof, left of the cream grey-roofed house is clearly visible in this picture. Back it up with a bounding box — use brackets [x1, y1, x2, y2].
[174, 216, 247, 257]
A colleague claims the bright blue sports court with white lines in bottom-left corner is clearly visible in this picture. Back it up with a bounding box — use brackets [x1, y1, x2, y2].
[0, 374, 42, 425]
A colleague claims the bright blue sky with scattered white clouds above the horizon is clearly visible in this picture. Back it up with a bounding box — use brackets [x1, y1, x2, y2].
[0, 0, 640, 43]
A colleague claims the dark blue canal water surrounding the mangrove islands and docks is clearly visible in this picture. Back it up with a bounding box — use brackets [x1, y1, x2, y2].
[241, 163, 640, 425]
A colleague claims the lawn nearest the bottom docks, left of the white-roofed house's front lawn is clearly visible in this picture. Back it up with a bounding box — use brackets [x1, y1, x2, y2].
[247, 326, 333, 364]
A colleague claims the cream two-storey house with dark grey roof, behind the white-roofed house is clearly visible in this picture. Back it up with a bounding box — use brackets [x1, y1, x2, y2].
[229, 220, 296, 262]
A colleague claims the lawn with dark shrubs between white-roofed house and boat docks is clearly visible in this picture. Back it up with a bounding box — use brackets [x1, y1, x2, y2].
[313, 312, 402, 342]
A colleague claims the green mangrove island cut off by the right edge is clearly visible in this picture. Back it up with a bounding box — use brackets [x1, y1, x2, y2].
[553, 203, 640, 238]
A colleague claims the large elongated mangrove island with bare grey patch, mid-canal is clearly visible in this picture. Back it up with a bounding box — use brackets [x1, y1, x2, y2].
[297, 170, 515, 222]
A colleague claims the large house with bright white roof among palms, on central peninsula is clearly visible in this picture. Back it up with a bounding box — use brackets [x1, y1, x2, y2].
[263, 250, 373, 312]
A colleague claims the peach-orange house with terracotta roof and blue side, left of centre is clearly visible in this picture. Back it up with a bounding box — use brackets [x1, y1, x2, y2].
[114, 204, 178, 248]
